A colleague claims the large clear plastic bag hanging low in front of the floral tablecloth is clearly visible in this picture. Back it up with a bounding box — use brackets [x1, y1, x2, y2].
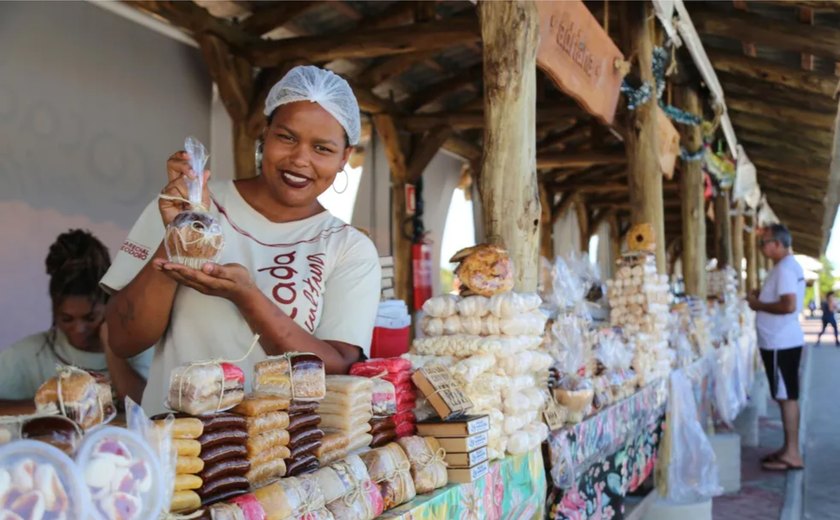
[667, 370, 723, 504]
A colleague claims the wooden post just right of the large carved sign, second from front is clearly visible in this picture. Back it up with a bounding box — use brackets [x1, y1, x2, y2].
[619, 2, 666, 273]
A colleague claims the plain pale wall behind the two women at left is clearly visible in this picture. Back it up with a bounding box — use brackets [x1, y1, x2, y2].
[0, 2, 212, 348]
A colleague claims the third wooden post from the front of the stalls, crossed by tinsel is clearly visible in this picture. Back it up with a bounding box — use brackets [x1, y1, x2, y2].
[675, 87, 706, 300]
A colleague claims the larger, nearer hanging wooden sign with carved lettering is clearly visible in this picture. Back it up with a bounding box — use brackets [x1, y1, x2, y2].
[536, 0, 624, 124]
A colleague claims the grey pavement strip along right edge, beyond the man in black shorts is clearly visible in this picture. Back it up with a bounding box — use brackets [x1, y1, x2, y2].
[803, 320, 840, 520]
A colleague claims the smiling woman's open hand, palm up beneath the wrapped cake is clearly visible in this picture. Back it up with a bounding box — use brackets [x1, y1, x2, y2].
[154, 259, 256, 305]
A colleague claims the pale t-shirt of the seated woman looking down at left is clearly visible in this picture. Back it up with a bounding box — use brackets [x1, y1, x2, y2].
[0, 329, 152, 401]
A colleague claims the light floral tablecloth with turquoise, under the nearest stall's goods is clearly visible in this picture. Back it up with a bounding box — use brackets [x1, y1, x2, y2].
[379, 449, 546, 520]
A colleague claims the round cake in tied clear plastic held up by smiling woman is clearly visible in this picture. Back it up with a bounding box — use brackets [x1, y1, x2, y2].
[163, 137, 225, 269]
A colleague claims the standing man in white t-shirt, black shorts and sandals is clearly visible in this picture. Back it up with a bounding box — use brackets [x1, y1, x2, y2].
[748, 224, 805, 471]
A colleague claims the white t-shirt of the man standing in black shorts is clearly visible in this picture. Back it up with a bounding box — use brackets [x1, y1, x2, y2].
[755, 255, 805, 350]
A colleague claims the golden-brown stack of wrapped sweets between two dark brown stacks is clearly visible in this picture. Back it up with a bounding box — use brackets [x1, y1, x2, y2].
[232, 395, 291, 486]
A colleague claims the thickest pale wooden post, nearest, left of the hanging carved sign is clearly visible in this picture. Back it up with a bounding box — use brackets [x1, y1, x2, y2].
[478, 0, 540, 292]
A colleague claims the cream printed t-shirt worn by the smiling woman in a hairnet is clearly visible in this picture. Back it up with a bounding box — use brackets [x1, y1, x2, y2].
[102, 181, 380, 414]
